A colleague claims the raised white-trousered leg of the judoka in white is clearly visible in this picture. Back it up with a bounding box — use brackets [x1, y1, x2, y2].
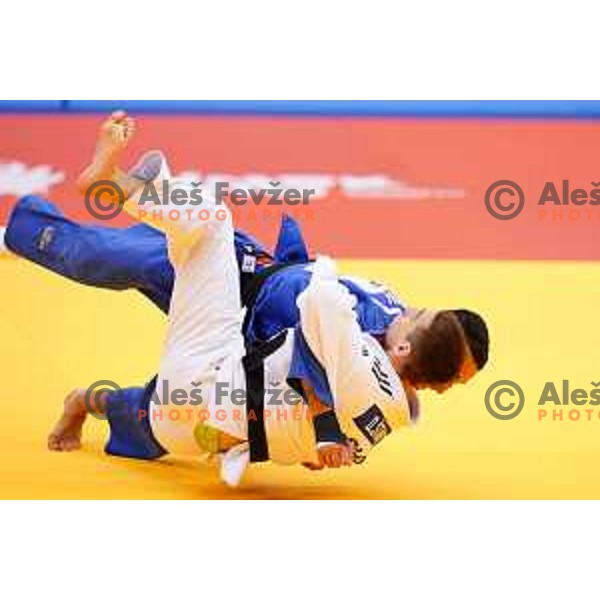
[125, 153, 247, 454]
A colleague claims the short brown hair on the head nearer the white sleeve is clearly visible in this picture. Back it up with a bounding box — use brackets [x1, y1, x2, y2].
[403, 310, 466, 385]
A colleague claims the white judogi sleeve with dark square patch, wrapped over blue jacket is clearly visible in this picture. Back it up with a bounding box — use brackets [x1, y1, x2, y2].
[298, 259, 410, 463]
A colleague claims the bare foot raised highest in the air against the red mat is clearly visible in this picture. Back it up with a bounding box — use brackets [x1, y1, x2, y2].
[77, 110, 135, 192]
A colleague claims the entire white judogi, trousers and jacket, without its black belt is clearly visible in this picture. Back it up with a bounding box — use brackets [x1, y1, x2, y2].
[126, 154, 410, 478]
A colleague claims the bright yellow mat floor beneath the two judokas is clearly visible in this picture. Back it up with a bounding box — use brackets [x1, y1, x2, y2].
[0, 258, 600, 499]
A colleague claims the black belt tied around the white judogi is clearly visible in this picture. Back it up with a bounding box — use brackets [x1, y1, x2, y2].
[242, 330, 287, 462]
